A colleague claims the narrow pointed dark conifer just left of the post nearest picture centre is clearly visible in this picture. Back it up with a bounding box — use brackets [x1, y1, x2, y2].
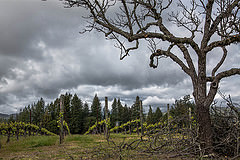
[91, 94, 102, 121]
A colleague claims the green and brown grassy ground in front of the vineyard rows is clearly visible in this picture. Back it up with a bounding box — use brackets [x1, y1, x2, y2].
[0, 134, 199, 160]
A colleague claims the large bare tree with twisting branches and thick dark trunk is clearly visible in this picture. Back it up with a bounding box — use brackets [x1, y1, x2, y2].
[64, 0, 240, 152]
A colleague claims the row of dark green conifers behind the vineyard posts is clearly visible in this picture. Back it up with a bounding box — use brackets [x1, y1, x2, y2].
[3, 93, 190, 134]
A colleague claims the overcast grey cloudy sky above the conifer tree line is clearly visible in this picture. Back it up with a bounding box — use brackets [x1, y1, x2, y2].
[0, 0, 240, 114]
